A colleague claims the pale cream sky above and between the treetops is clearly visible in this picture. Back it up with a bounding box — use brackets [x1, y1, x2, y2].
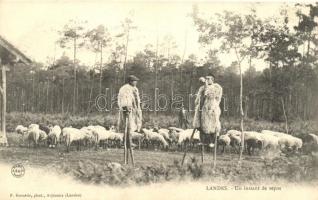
[0, 0, 308, 70]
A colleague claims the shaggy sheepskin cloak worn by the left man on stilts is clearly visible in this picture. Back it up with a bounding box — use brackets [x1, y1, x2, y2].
[118, 84, 142, 132]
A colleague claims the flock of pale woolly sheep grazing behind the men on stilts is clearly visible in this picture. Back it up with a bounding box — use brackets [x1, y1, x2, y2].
[15, 124, 318, 155]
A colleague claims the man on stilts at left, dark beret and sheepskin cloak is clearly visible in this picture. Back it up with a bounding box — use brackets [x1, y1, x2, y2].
[118, 75, 142, 165]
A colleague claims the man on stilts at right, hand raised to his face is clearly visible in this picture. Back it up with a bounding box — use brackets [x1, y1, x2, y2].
[193, 74, 222, 169]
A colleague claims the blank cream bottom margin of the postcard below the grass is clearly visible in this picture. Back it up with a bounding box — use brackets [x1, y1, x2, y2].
[0, 163, 318, 200]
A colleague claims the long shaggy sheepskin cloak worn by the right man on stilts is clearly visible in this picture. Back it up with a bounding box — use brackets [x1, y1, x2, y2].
[193, 83, 222, 135]
